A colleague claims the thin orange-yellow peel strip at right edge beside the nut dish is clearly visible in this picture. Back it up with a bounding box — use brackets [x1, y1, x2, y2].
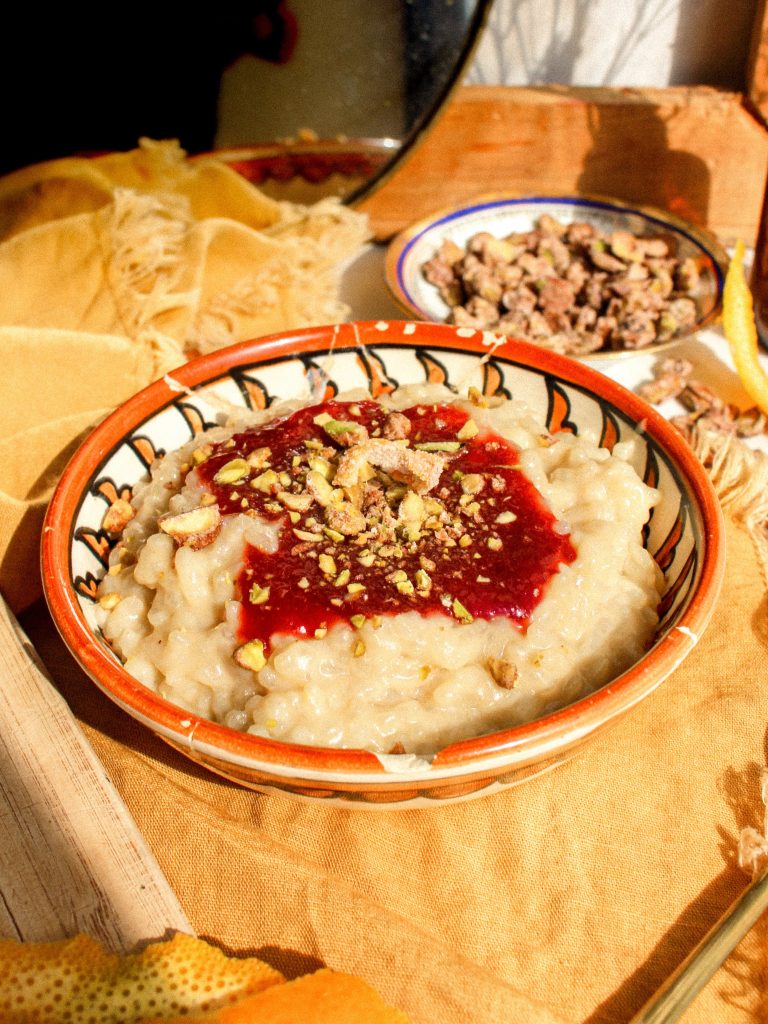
[723, 240, 768, 415]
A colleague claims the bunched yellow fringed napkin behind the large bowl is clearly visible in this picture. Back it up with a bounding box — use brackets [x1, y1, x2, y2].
[0, 139, 369, 611]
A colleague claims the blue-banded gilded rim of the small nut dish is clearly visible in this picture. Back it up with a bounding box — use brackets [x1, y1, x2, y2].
[386, 193, 728, 360]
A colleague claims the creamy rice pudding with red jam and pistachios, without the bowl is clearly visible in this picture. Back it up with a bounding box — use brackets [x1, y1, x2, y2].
[98, 385, 663, 755]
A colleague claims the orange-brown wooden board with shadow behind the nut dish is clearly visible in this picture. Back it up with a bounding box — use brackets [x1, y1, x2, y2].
[360, 86, 768, 246]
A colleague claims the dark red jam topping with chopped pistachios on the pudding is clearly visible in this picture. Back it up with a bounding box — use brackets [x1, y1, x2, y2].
[188, 393, 575, 671]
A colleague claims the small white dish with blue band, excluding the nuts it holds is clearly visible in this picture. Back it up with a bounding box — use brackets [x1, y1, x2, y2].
[386, 196, 727, 358]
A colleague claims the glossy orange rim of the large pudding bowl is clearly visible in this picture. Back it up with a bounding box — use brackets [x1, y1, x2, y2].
[42, 322, 724, 788]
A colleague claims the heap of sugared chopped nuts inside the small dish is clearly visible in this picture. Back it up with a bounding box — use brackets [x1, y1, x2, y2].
[422, 214, 700, 354]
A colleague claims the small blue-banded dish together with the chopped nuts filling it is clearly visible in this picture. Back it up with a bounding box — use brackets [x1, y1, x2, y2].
[386, 196, 726, 358]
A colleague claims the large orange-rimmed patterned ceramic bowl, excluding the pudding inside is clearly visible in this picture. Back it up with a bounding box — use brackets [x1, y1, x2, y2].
[42, 322, 723, 807]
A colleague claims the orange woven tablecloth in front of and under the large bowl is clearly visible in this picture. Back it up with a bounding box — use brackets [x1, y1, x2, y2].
[16, 505, 768, 1024]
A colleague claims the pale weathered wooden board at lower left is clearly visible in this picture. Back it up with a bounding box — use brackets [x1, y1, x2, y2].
[0, 599, 191, 952]
